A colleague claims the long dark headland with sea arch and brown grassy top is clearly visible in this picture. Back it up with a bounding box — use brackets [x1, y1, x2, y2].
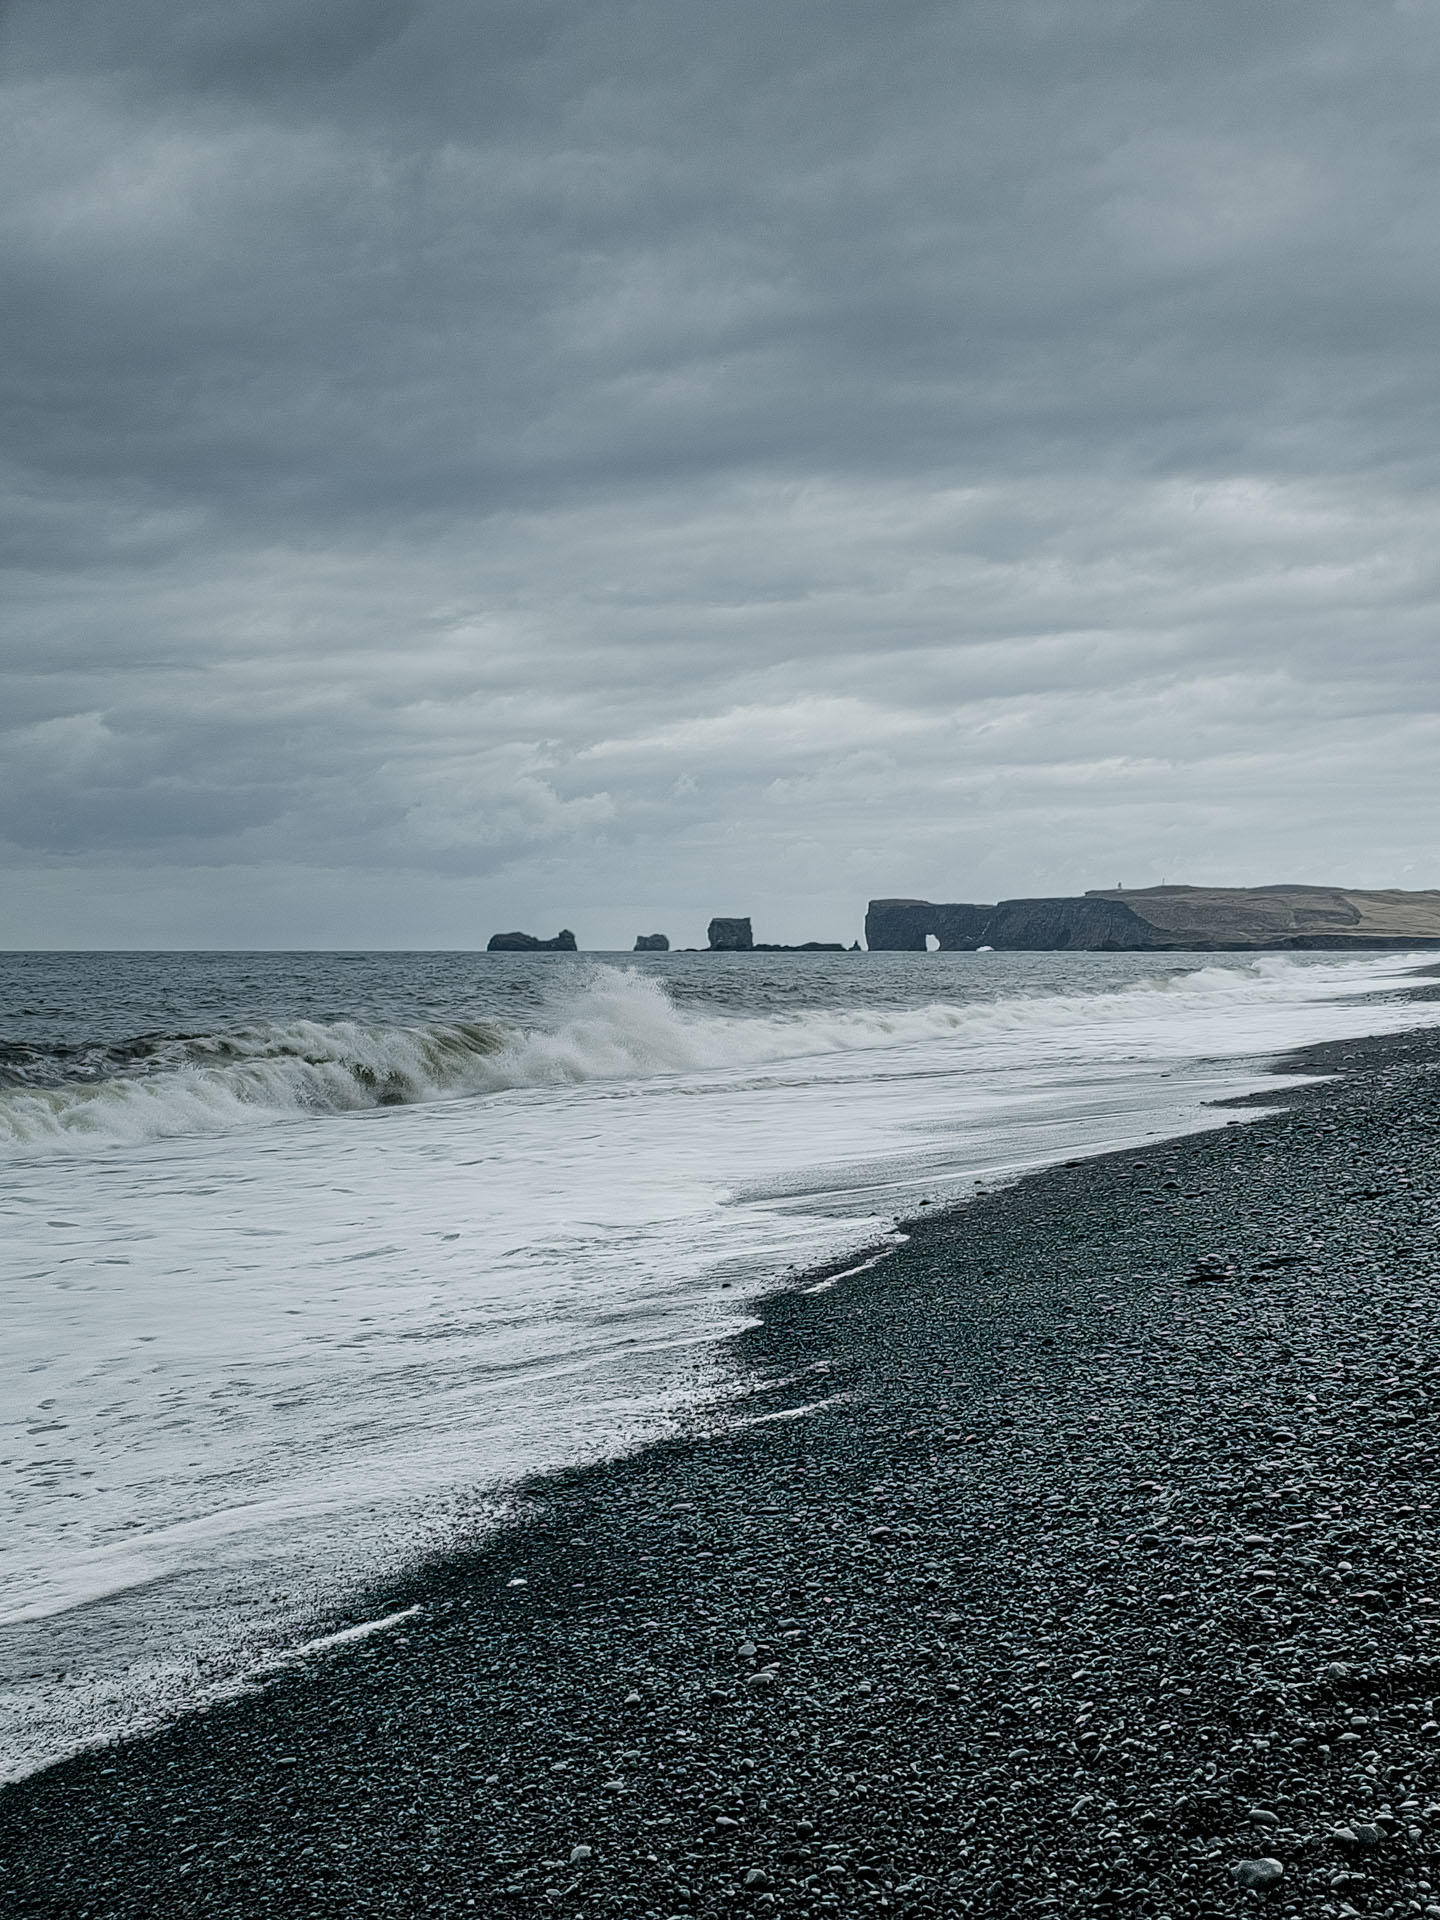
[866, 885, 1440, 952]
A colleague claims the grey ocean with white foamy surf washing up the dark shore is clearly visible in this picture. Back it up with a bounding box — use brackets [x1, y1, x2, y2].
[0, 952, 1440, 1778]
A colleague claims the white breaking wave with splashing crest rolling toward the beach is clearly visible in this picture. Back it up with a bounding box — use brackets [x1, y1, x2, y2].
[0, 944, 1390, 1154]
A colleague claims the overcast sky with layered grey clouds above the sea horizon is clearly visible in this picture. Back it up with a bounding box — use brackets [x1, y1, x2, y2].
[0, 0, 1440, 948]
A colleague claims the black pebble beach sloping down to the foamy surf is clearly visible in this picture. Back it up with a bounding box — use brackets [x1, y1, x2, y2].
[0, 1033, 1440, 1920]
